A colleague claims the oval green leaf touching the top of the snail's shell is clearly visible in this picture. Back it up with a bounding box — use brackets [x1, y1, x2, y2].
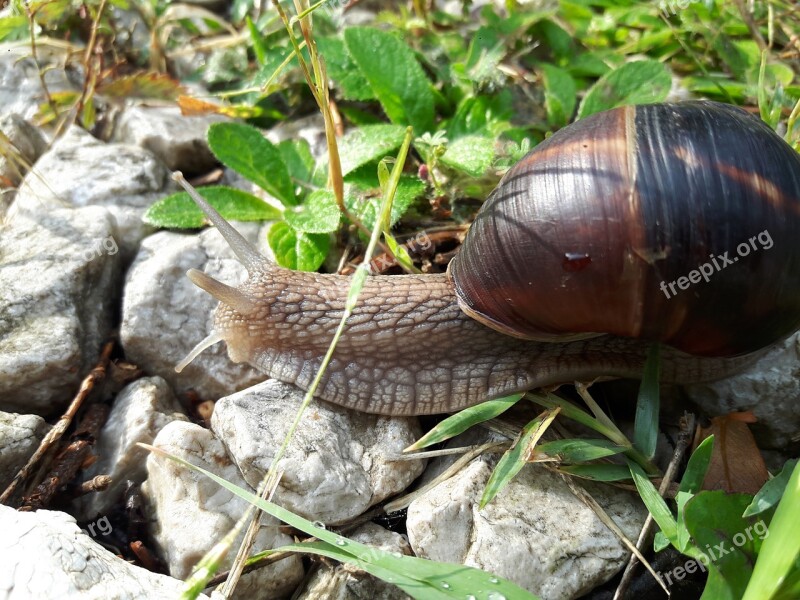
[578, 60, 672, 119]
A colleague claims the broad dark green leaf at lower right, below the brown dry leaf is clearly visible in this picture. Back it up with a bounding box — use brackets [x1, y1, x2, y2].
[684, 491, 764, 599]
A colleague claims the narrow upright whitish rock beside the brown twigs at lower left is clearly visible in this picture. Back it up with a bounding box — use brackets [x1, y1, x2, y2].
[75, 377, 186, 520]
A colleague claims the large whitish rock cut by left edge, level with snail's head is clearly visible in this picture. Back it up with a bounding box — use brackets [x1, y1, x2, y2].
[0, 203, 121, 415]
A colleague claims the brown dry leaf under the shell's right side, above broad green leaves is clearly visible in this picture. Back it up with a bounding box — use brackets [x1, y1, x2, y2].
[695, 412, 769, 494]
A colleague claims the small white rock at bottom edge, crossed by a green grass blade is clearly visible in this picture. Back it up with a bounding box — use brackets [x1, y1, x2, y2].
[298, 523, 412, 600]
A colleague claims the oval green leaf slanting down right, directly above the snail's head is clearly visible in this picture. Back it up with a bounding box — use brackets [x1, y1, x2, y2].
[208, 123, 297, 206]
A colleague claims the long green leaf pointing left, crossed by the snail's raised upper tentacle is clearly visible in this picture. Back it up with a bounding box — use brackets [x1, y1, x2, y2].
[142, 186, 281, 229]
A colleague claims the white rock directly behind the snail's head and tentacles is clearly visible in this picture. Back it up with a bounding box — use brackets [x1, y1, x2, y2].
[120, 223, 266, 399]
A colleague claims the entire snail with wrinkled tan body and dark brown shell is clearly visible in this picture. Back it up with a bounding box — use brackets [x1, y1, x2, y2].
[179, 102, 800, 415]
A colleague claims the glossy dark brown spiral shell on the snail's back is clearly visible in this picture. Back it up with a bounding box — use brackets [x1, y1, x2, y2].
[449, 102, 800, 356]
